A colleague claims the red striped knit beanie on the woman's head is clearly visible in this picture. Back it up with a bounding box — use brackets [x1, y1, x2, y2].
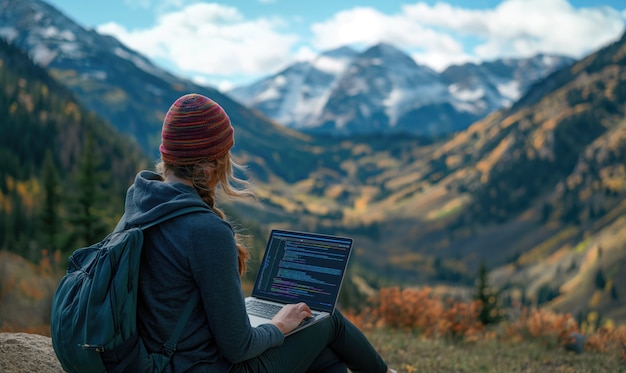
[159, 93, 235, 166]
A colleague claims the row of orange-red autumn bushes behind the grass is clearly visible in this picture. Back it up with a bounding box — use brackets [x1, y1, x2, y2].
[345, 287, 626, 362]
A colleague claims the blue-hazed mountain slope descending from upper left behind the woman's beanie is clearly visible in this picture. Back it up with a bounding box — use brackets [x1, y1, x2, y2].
[0, 0, 314, 179]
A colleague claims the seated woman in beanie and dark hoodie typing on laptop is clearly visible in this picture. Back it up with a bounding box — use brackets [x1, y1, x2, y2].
[123, 94, 391, 373]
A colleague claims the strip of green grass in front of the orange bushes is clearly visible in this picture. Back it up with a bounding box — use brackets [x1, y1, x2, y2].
[365, 328, 626, 373]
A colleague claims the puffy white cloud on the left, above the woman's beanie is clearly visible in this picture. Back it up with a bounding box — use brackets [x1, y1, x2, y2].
[98, 3, 298, 84]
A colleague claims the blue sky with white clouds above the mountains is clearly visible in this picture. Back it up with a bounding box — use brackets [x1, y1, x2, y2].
[43, 0, 626, 91]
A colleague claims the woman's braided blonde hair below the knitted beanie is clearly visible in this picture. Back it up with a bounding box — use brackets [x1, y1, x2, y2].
[156, 153, 256, 276]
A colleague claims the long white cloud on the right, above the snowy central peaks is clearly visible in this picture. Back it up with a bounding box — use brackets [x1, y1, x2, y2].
[311, 0, 626, 70]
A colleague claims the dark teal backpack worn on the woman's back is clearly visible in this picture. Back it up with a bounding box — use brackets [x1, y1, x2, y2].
[50, 207, 207, 373]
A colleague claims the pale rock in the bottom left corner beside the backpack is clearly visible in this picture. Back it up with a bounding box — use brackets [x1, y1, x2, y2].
[0, 333, 64, 373]
